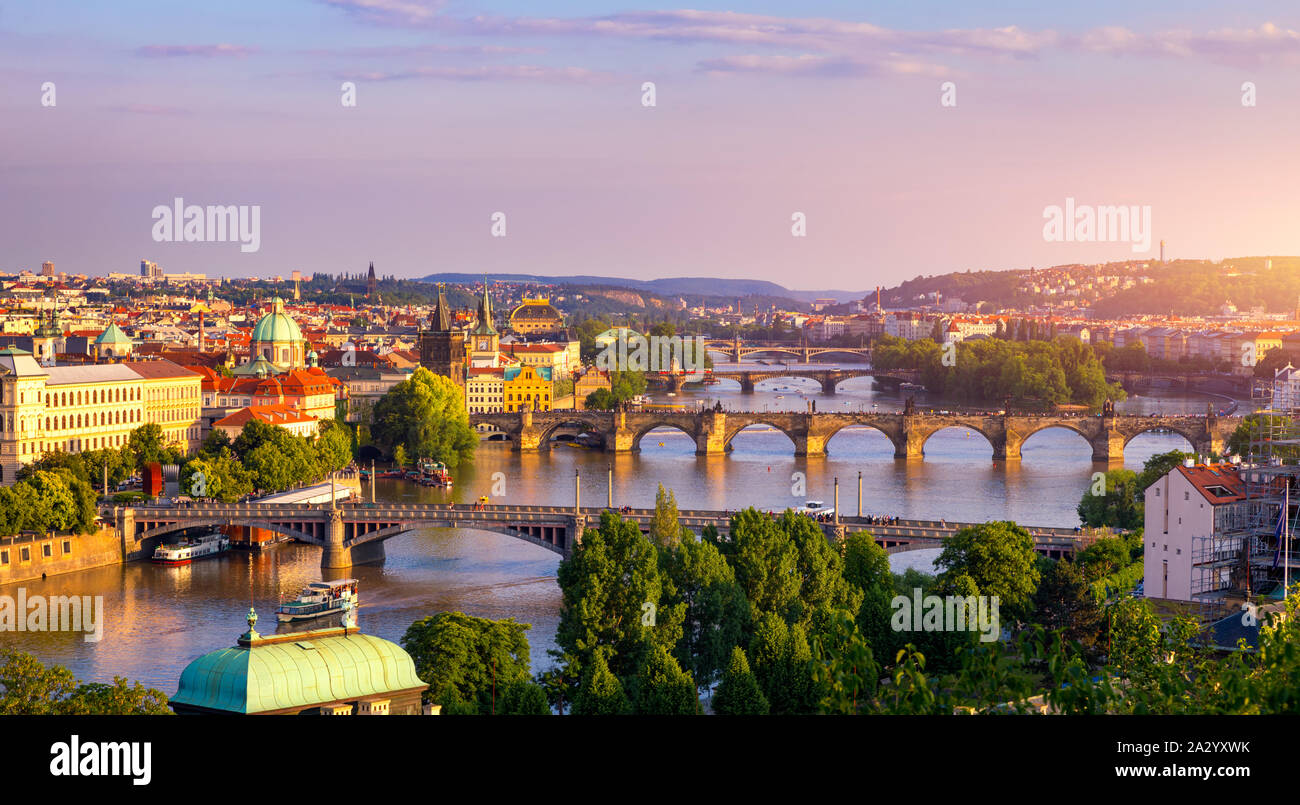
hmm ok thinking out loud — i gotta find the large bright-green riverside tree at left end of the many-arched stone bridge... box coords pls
[371,367,478,467]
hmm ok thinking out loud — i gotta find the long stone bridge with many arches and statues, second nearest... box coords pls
[469,411,1240,463]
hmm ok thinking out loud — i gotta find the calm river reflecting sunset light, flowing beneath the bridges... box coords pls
[0,378,1242,694]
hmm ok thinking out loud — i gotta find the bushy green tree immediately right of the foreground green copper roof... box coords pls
[402,613,533,715]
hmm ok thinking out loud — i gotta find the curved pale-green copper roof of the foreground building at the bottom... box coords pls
[170,632,425,714]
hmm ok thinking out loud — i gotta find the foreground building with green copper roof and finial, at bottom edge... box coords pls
[168,609,429,715]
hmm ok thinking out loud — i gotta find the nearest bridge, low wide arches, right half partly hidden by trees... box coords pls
[113,501,1083,568]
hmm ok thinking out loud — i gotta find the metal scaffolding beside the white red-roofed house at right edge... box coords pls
[1192,381,1300,618]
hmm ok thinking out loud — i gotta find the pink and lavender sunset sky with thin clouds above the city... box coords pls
[0,0,1300,290]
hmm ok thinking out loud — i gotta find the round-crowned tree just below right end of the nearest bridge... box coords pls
[935,521,1039,618]
